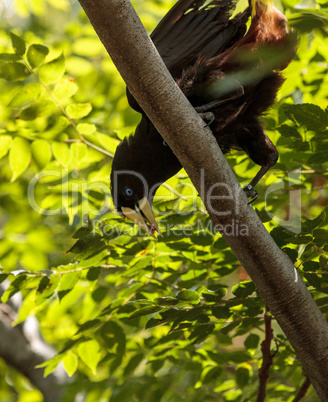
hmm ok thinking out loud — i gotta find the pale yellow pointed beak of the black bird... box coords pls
[122,197,163,239]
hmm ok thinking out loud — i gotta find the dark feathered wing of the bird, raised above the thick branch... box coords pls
[151,0,250,78]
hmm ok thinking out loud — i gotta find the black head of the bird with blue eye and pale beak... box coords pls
[111,139,162,238]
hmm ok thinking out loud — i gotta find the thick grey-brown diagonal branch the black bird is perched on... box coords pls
[75,0,328,400]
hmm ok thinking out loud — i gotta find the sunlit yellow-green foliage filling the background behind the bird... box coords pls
[0,0,328,401]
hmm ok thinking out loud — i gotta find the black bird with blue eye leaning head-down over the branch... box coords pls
[111,0,296,237]
